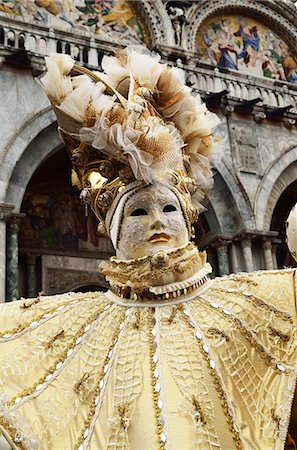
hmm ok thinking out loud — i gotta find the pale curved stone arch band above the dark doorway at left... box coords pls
[0,107,57,206]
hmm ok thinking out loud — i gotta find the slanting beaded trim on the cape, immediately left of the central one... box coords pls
[74,310,130,450]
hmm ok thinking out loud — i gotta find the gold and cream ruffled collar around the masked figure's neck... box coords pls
[100,243,212,303]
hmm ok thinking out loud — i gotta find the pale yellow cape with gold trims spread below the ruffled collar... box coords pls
[0,270,296,450]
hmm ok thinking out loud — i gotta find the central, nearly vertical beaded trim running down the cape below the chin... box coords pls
[149,308,168,450]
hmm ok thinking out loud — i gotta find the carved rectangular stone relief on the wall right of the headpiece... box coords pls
[230,123,259,174]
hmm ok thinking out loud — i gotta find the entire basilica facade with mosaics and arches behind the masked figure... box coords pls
[0,0,297,301]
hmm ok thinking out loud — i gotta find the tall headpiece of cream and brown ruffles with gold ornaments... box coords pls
[41,47,218,237]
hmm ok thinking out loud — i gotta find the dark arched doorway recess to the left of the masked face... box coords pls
[19,148,113,297]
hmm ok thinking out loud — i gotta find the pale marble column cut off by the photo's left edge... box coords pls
[0,203,14,303]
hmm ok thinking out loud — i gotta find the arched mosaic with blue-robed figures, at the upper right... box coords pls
[196,15,297,84]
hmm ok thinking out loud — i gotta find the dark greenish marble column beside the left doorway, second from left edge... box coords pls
[6,213,25,302]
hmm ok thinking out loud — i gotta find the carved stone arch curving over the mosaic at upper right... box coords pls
[185,0,297,51]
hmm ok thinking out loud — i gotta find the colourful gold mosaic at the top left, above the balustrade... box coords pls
[0,0,150,46]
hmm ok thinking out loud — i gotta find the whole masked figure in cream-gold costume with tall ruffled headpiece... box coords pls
[0,49,296,450]
